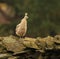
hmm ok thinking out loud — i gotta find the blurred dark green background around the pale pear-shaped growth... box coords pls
[0,0,60,37]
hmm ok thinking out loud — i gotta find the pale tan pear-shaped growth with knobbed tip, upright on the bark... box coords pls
[16,13,28,37]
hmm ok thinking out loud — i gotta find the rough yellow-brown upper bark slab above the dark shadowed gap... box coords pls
[2,36,60,52]
